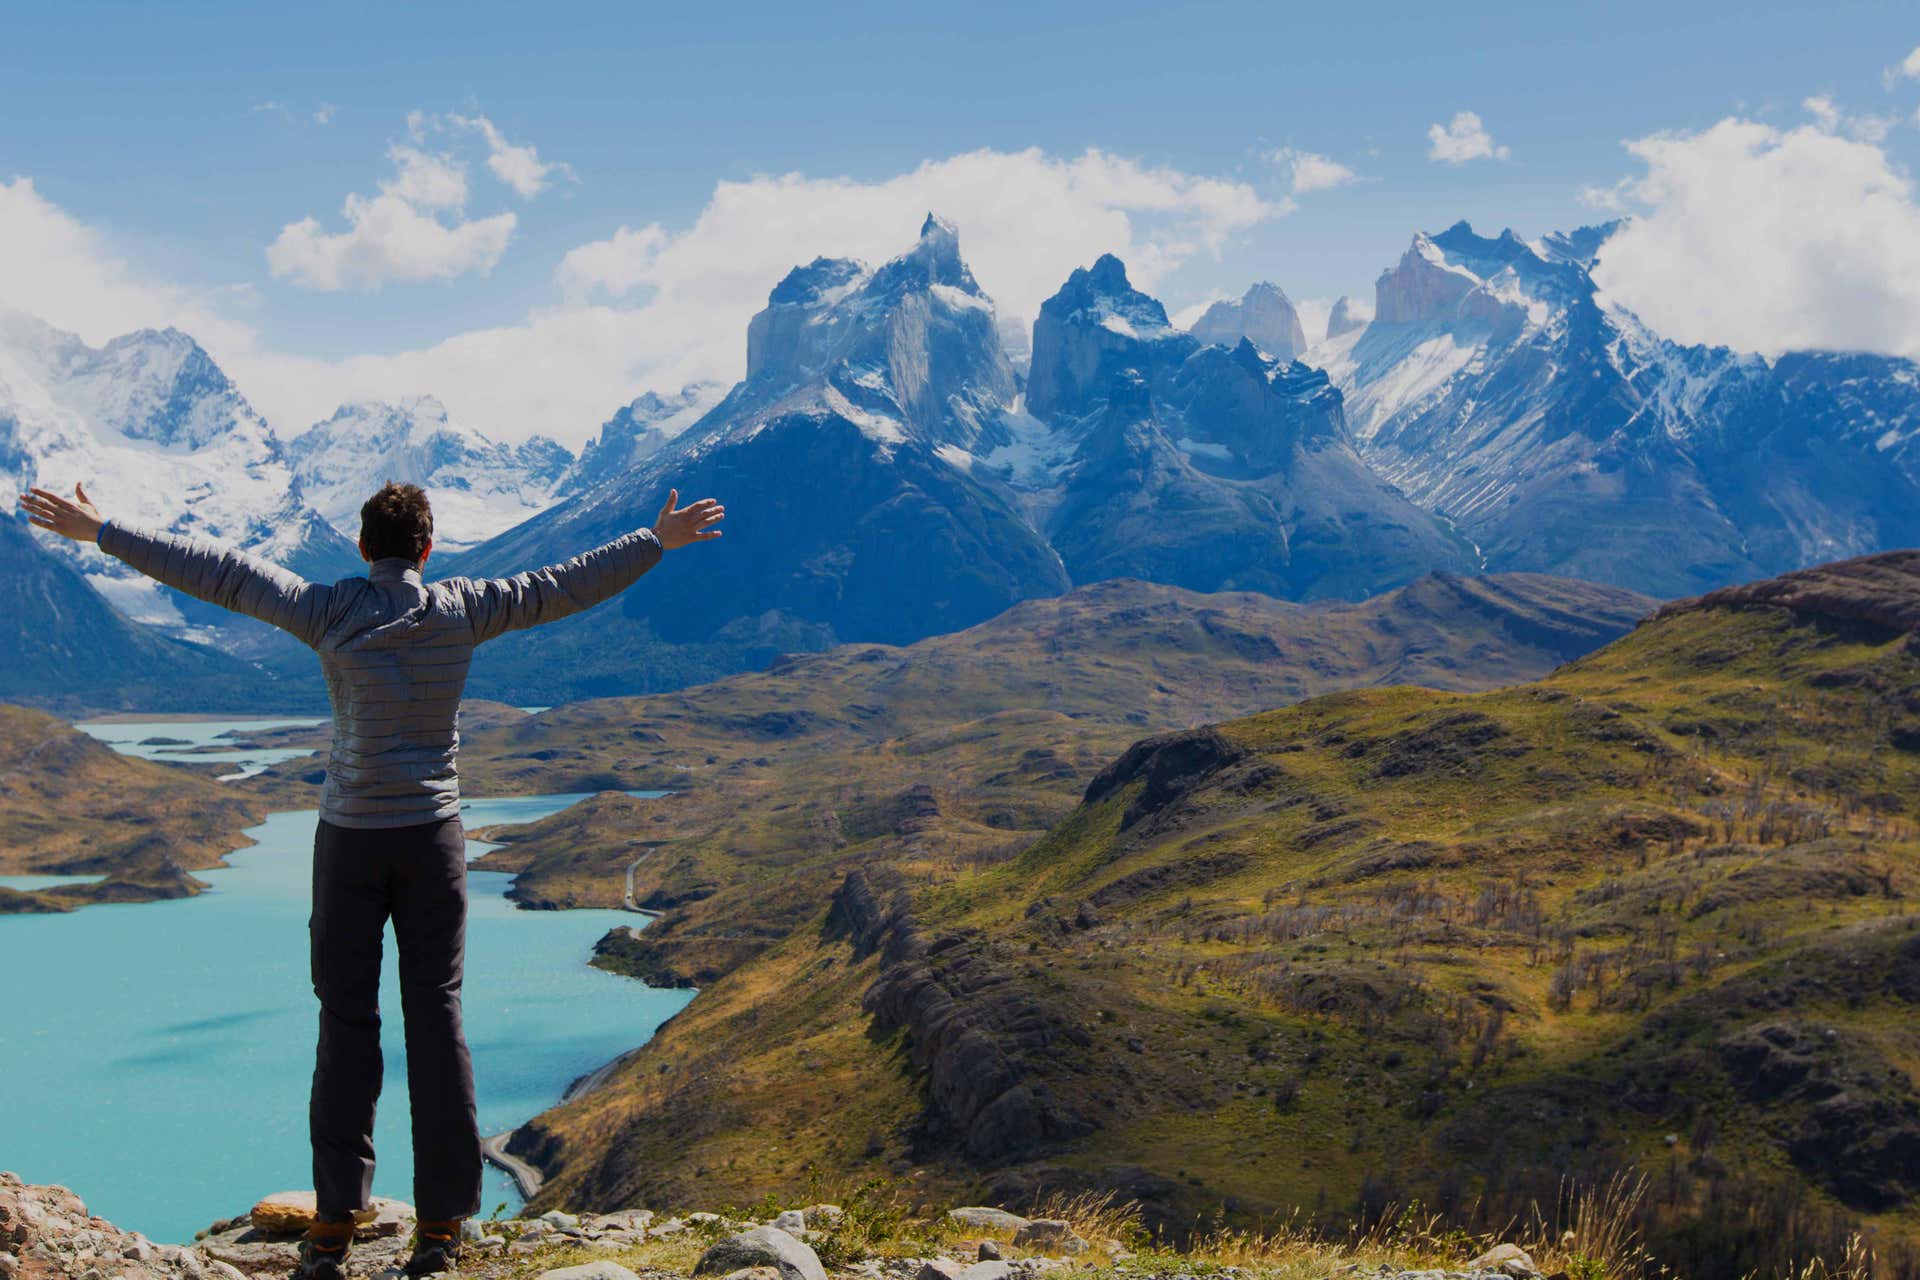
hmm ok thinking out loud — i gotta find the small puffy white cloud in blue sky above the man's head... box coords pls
[267,146,515,294]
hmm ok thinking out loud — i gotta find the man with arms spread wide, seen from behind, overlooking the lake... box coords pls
[19,484,726,1280]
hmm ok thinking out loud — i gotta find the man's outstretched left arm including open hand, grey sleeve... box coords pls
[19,486,330,645]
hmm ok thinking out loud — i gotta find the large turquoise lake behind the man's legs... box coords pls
[0,723,691,1242]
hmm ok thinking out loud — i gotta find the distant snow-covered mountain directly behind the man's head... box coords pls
[286,395,574,551]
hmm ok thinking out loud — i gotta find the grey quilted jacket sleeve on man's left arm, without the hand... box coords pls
[100,520,332,645]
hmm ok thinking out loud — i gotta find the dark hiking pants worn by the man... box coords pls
[307,818,480,1221]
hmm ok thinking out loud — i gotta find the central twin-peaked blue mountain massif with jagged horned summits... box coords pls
[447,215,1471,667]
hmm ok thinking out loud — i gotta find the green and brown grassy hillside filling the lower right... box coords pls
[520,553,1920,1276]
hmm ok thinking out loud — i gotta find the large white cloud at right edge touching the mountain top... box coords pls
[1596,113,1920,355]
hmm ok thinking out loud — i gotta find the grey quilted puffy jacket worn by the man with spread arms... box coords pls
[100,520,660,827]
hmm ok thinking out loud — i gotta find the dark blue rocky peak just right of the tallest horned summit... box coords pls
[1027,255,1473,599]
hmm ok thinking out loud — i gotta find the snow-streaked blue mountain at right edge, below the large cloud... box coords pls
[1309,223,1920,595]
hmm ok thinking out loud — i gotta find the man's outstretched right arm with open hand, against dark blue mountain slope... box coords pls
[460,489,726,645]
